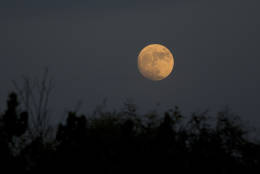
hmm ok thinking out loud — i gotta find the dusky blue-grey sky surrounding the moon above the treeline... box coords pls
[0,0,260,128]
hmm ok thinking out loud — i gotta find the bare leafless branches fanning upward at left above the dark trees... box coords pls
[13,68,54,140]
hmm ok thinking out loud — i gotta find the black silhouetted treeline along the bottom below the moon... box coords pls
[0,93,260,174]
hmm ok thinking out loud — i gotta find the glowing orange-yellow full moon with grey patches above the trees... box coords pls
[138,44,174,81]
